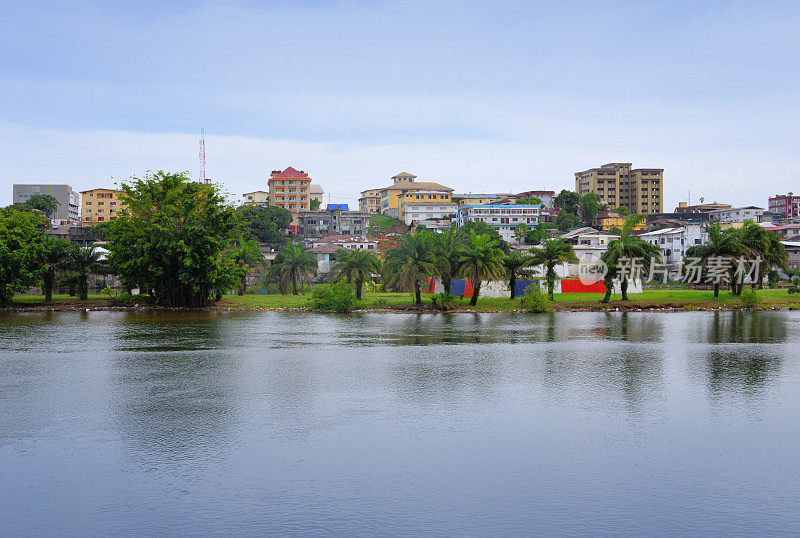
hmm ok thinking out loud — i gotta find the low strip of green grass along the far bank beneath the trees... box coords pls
[3,289,800,312]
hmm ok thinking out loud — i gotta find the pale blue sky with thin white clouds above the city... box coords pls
[0,0,800,207]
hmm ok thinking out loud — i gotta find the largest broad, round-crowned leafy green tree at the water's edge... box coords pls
[107,171,241,308]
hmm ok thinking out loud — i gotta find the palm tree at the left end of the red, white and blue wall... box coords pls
[384,230,439,305]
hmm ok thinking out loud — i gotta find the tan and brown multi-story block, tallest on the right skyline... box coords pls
[575,163,664,215]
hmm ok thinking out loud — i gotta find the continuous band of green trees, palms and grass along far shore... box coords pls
[0,172,800,311]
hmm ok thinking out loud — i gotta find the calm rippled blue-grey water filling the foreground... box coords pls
[0,312,800,535]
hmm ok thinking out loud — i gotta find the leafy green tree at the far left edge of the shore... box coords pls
[0,208,47,305]
